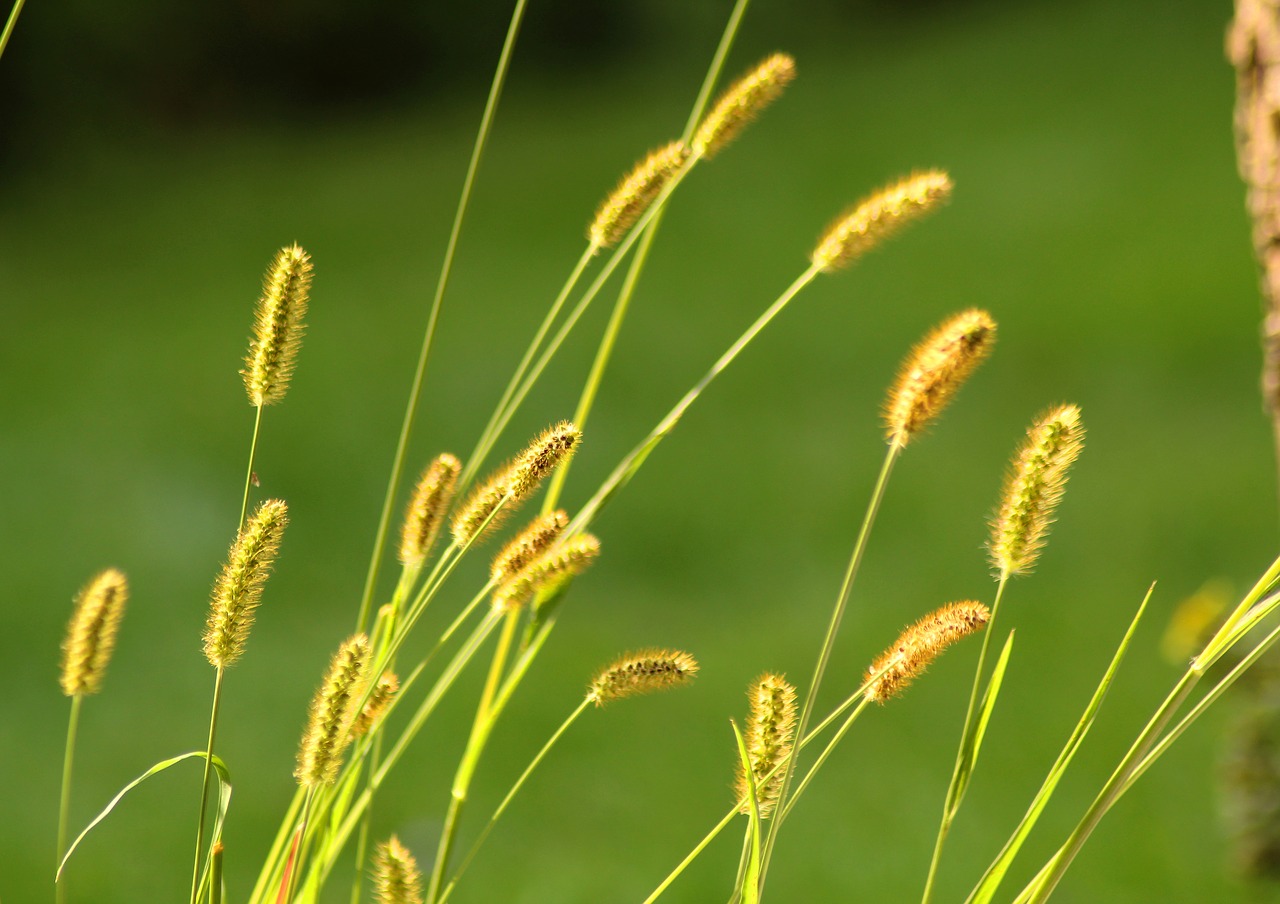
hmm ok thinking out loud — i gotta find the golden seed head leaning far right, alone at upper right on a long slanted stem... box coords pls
[809,169,951,267]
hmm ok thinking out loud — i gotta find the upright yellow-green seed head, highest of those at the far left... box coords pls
[241,245,311,407]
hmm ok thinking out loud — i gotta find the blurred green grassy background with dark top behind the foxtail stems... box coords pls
[0,0,1277,904]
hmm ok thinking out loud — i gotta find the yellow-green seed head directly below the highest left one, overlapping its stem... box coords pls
[205,499,289,668]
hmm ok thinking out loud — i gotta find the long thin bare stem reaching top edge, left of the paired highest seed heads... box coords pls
[356,0,526,631]
